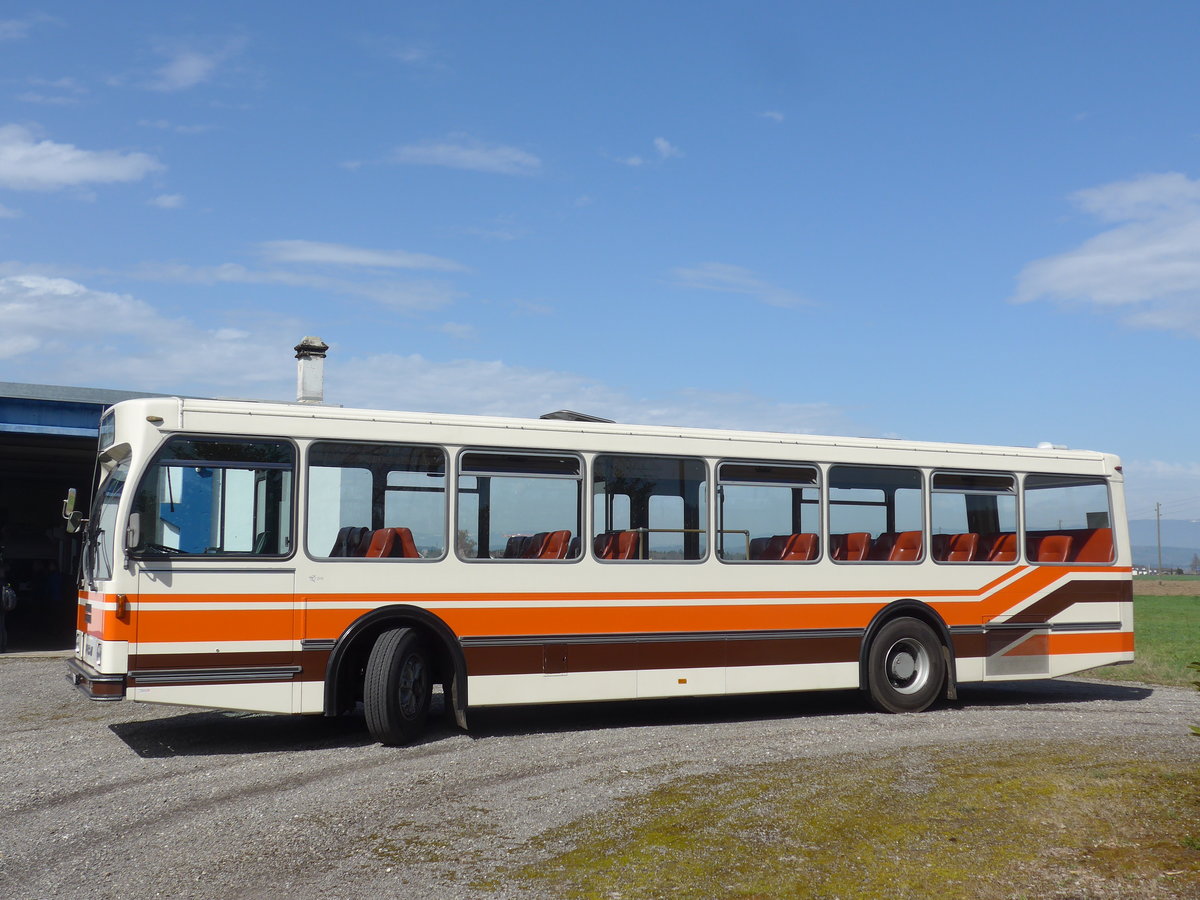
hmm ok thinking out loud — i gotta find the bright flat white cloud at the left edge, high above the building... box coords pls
[0,125,164,191]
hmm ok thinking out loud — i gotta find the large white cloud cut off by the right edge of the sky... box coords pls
[1012,173,1200,337]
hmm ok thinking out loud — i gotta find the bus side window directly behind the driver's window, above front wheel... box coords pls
[307,440,446,559]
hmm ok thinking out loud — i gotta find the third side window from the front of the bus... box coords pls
[455,451,583,562]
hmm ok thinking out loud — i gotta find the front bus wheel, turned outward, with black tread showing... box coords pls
[362,628,433,746]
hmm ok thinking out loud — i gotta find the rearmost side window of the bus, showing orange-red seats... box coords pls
[1025,475,1114,565]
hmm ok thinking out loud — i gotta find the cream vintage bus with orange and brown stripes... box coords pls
[68,397,1133,744]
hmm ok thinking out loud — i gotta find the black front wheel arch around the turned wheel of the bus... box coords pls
[325,604,467,728]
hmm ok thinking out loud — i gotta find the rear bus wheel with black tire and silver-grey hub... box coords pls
[866,616,946,713]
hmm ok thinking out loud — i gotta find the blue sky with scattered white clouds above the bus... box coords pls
[0,2,1200,518]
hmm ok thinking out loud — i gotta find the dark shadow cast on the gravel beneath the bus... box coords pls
[109,679,1153,758]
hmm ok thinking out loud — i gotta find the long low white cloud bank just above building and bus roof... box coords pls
[0,266,857,433]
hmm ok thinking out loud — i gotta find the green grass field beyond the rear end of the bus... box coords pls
[1087,596,1200,685]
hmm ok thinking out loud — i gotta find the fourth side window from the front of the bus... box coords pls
[592,455,708,560]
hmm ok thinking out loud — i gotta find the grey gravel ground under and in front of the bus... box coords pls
[0,656,1200,900]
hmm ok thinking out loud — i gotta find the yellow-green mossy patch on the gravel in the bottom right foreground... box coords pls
[489,743,1200,900]
